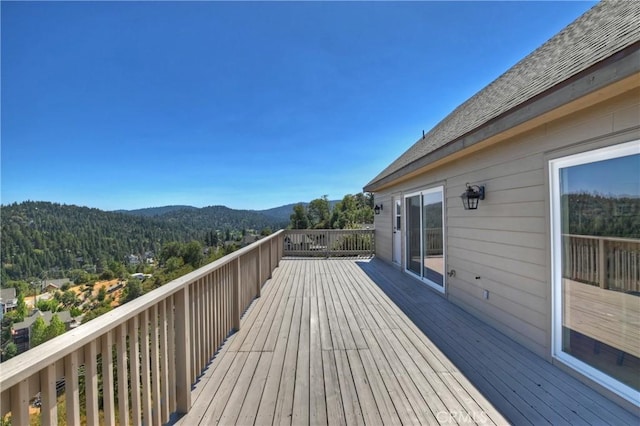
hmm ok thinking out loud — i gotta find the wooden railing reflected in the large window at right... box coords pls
[562,234,640,292]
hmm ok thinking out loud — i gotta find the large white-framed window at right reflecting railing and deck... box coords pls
[550,141,640,404]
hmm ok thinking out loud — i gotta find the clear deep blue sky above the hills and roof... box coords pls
[1,1,594,210]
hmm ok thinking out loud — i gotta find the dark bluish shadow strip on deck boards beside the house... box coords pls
[357,259,640,425]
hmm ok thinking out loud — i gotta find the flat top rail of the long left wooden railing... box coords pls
[0,230,284,390]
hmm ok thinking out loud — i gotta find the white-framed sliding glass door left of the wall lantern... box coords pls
[405,187,444,291]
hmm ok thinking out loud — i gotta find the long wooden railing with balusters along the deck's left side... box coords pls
[0,231,285,425]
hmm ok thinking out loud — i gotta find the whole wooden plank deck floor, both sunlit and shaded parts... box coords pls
[175,259,639,425]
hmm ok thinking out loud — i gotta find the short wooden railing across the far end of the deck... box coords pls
[283,229,375,257]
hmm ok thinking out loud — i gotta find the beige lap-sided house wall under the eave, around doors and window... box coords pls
[375,88,640,359]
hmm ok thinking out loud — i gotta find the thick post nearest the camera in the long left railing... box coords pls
[175,286,191,414]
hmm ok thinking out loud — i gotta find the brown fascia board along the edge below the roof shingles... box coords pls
[364,43,640,192]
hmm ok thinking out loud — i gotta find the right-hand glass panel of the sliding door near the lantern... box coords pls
[422,191,444,286]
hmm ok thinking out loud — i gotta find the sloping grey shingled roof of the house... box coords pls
[364,1,640,192]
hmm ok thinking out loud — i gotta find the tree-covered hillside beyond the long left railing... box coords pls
[0,201,286,282]
